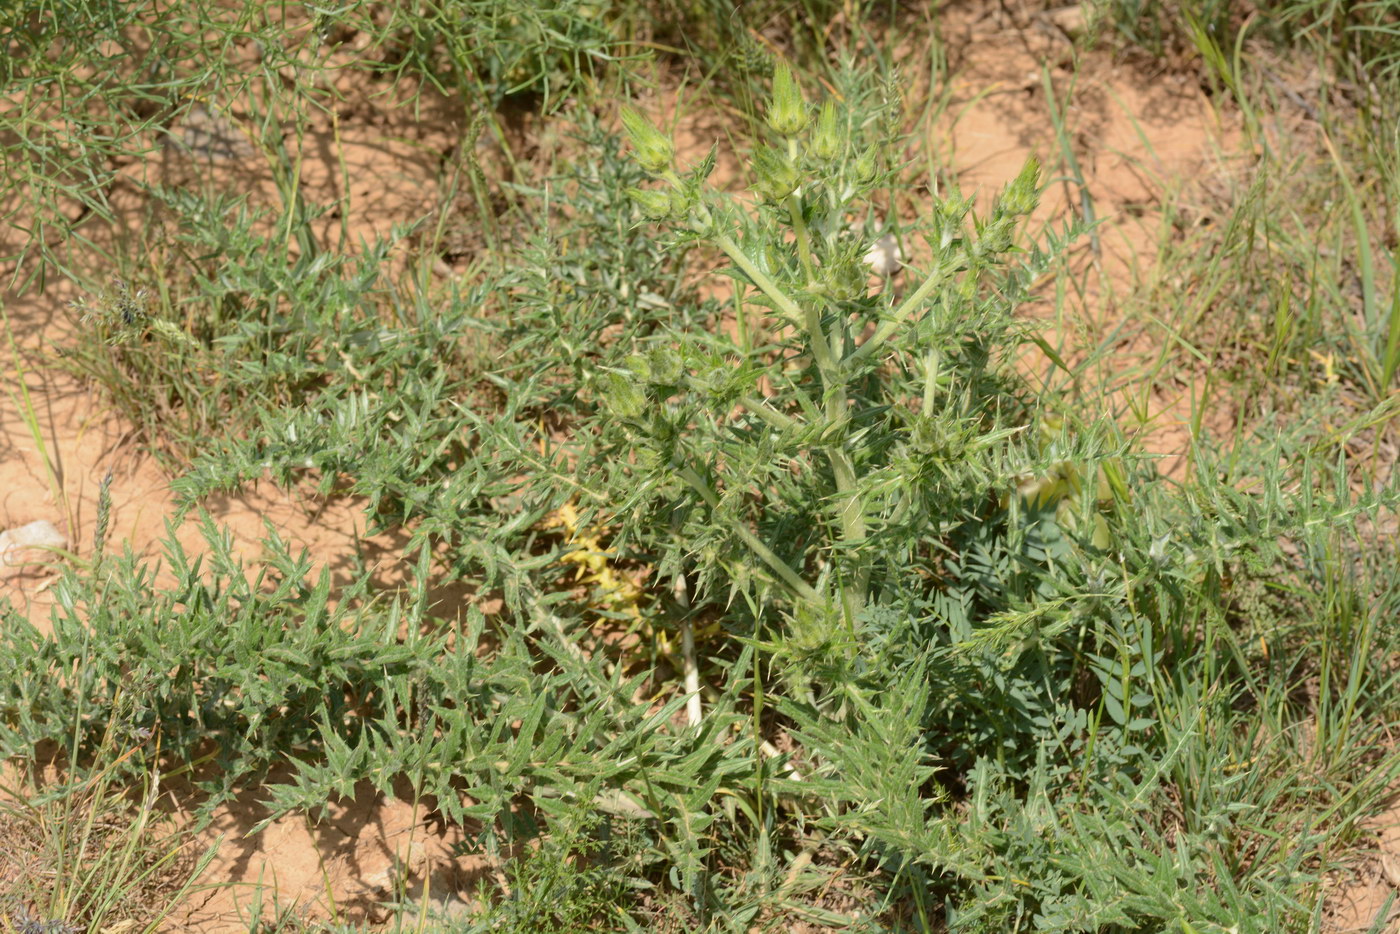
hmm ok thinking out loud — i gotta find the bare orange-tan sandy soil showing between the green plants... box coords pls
[0,5,1400,933]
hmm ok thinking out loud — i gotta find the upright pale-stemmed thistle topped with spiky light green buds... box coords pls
[605,66,1046,658]
